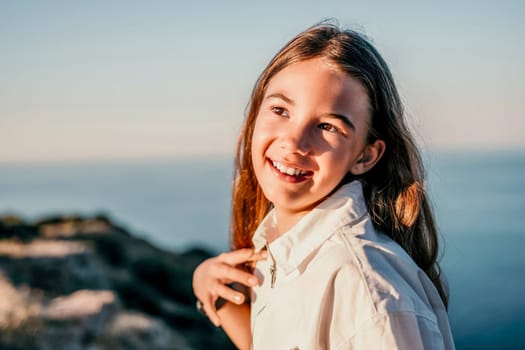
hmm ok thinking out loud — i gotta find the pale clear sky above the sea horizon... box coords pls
[0,0,525,162]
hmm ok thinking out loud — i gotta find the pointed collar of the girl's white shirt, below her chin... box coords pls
[252,181,367,274]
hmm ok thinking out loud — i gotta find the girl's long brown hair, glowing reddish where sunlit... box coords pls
[231,23,448,305]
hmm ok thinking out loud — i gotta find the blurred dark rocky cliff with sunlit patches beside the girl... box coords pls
[0,216,234,350]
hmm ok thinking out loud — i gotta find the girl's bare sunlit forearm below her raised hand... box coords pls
[218,303,252,350]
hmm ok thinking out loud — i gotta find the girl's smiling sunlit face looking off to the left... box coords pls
[251,58,378,226]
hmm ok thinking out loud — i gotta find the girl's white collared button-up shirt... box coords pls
[251,181,454,350]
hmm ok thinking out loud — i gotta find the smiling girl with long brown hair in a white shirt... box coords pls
[193,24,454,349]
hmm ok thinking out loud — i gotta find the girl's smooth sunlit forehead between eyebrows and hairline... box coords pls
[265,58,370,114]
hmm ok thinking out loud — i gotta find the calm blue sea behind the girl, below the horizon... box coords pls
[0,150,525,349]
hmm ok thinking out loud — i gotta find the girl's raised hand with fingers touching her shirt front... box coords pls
[193,248,267,327]
